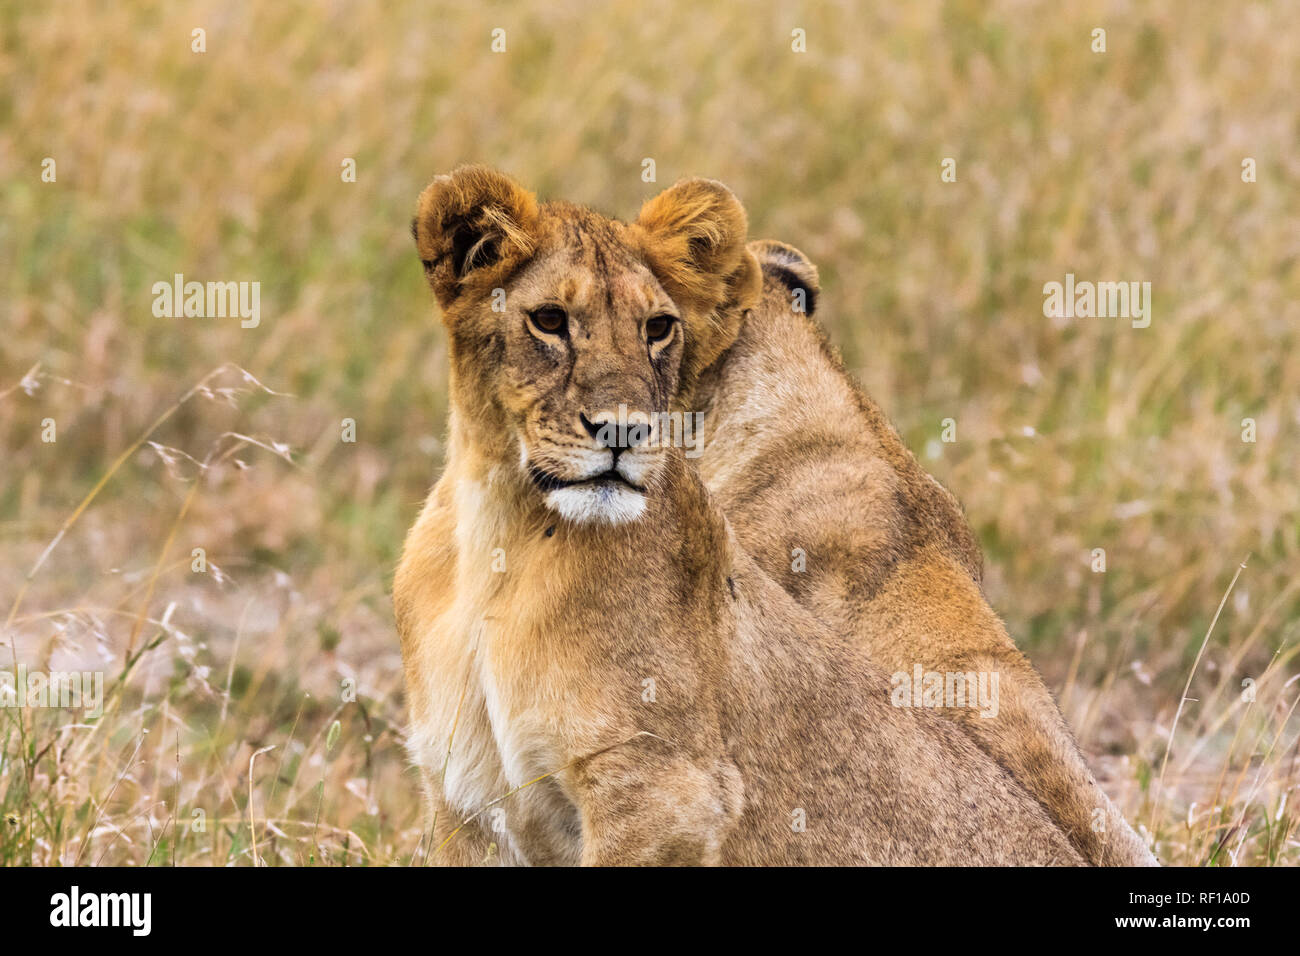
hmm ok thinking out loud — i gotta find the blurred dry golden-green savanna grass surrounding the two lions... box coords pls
[0,0,1300,865]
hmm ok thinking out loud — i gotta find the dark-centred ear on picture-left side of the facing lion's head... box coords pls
[411,166,538,308]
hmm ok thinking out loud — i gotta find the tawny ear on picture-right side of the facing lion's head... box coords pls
[634,179,763,377]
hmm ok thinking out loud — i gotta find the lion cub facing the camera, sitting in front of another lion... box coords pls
[394,168,1080,865]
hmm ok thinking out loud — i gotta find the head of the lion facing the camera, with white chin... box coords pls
[412,166,762,524]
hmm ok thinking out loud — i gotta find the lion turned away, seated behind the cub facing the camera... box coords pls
[696,242,1156,865]
